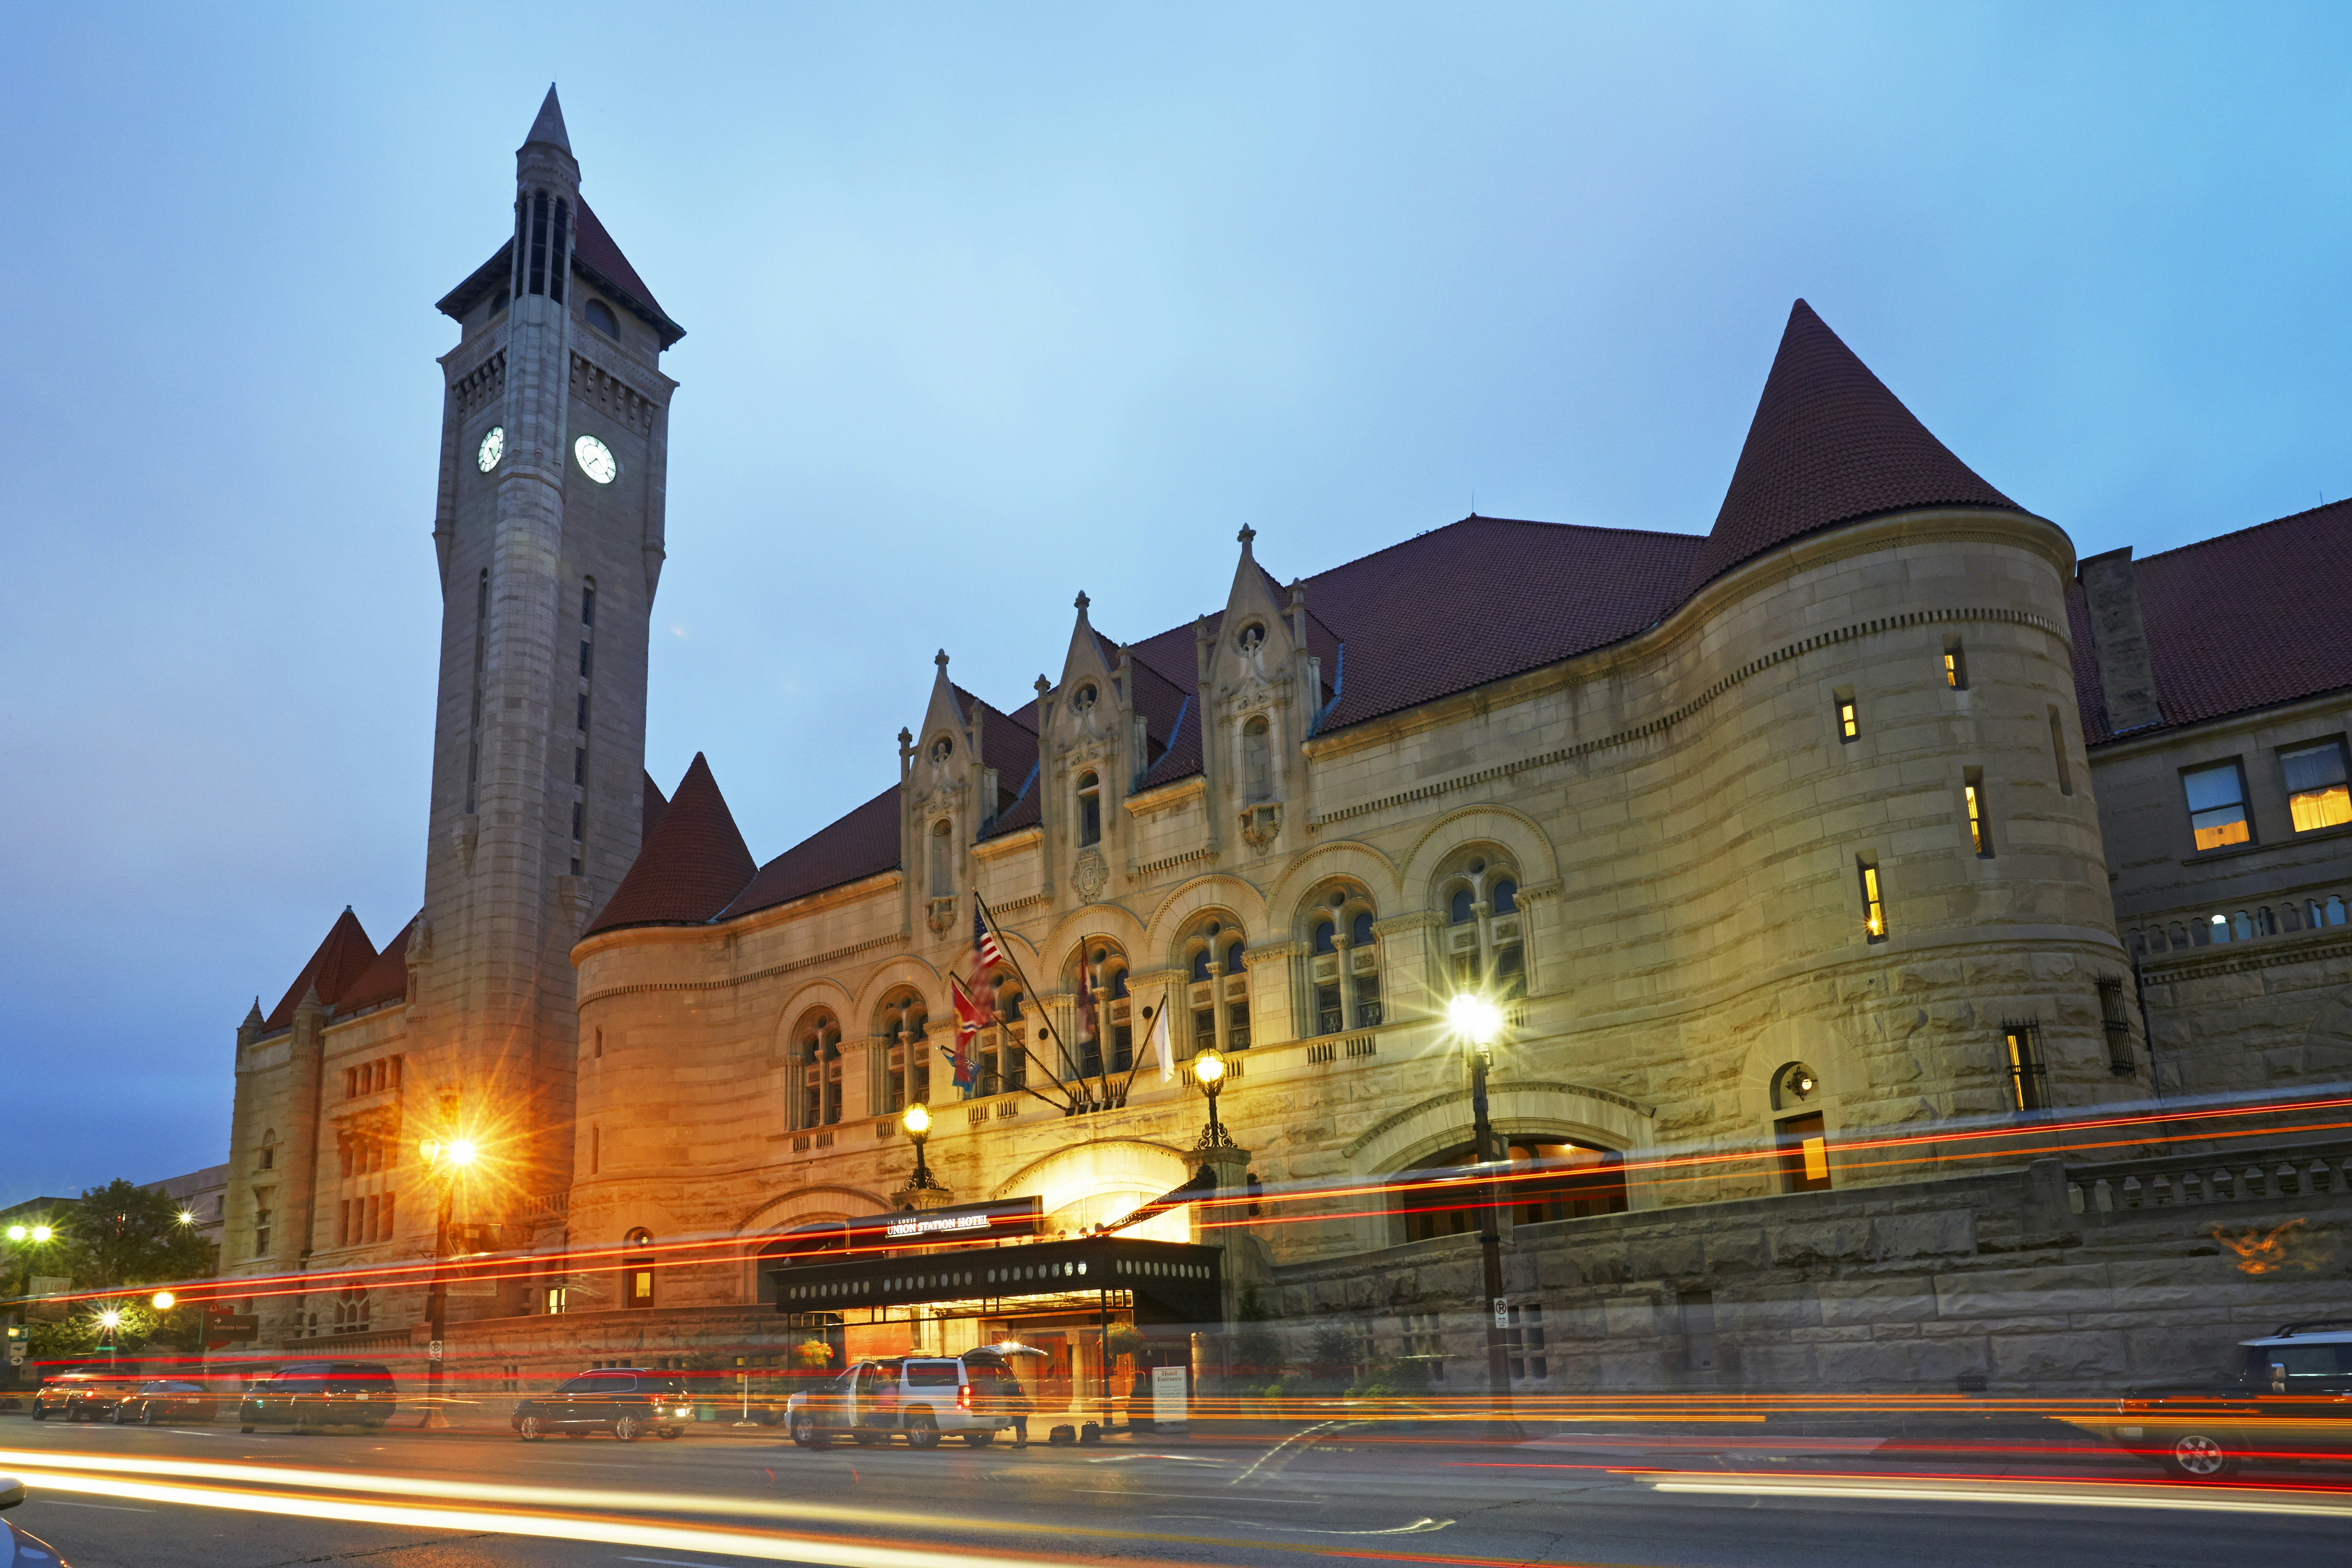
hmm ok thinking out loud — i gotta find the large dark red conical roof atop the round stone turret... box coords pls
[1687,298,2025,593]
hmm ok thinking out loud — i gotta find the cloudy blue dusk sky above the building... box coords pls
[0,0,2352,1201]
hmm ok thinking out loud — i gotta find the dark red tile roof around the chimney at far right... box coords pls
[2067,501,2352,745]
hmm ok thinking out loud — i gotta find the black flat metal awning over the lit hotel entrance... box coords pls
[769,1236,1225,1326]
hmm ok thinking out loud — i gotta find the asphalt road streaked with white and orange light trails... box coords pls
[0,1415,2352,1568]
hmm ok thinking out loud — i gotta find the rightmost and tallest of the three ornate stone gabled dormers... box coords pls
[1197,529,1322,851]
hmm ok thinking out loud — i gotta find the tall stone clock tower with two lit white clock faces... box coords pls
[407,87,684,1213]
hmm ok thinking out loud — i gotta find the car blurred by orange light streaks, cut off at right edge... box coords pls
[2108,1319,2352,1481]
